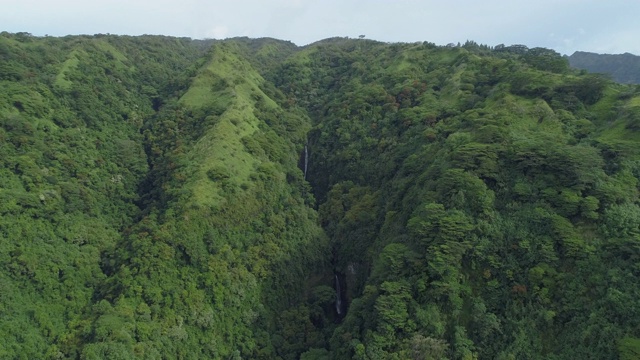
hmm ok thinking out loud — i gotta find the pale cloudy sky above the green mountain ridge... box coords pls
[0,0,640,55]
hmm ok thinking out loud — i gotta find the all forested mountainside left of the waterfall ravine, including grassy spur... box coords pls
[0,34,326,359]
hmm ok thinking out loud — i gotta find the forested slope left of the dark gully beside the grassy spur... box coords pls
[0,34,198,359]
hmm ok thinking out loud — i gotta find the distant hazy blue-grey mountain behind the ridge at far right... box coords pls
[569,51,640,84]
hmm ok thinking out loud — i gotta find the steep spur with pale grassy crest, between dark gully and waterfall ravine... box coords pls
[77,43,326,358]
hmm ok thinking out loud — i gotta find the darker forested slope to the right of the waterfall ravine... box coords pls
[281,39,640,359]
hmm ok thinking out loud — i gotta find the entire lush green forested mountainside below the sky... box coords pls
[0,32,640,360]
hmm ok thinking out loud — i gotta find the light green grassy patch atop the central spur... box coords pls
[180,45,277,208]
